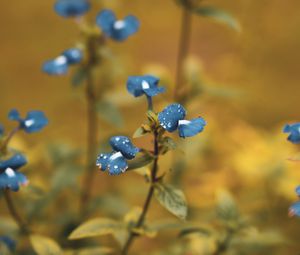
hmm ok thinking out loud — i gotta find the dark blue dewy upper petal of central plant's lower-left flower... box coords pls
[109,136,140,159]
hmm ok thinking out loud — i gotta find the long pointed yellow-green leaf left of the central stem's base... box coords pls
[69,218,122,240]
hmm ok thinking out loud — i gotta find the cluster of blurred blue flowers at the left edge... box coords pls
[0,109,48,191]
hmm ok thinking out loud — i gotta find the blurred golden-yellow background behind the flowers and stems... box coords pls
[0,0,300,254]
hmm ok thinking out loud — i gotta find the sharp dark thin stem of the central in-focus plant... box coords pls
[121,130,159,255]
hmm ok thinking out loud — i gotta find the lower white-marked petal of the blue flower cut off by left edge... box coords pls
[0,168,28,191]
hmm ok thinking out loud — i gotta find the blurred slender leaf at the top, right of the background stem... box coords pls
[192,6,241,32]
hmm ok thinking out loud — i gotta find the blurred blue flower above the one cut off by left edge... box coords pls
[8,109,48,133]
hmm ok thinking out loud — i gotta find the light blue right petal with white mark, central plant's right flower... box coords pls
[178,117,206,138]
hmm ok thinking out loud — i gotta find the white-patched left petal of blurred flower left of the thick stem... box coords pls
[42,56,68,75]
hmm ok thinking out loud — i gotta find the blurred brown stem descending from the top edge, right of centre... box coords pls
[174,7,192,103]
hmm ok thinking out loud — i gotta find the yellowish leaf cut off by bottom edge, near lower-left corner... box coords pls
[30,235,62,255]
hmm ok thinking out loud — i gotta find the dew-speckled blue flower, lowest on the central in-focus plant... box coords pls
[96,136,140,175]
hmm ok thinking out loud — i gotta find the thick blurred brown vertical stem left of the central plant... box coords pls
[80,68,97,214]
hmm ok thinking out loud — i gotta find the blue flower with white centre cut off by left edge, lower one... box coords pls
[0,153,28,191]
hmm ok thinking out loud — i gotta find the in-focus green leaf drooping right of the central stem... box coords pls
[155,183,187,220]
